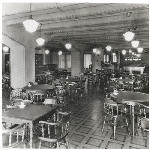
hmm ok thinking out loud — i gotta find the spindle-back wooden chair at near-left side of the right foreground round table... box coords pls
[102,98,129,139]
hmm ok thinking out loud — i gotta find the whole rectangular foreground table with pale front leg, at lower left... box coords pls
[2,104,55,149]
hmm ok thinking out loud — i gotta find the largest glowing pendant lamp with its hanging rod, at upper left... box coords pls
[23,3,39,33]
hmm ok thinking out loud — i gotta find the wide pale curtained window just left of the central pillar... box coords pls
[59,54,71,68]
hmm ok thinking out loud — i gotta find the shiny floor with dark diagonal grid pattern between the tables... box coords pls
[2,85,148,149]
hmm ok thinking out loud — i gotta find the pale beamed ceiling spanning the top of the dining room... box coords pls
[2,3,149,50]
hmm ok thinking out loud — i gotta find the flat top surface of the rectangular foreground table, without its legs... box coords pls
[2,104,55,121]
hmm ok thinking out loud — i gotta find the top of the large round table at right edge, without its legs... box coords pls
[111,91,149,102]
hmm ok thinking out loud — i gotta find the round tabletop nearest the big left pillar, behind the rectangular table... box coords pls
[23,84,55,90]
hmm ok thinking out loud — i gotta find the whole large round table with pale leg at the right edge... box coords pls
[110,91,149,136]
